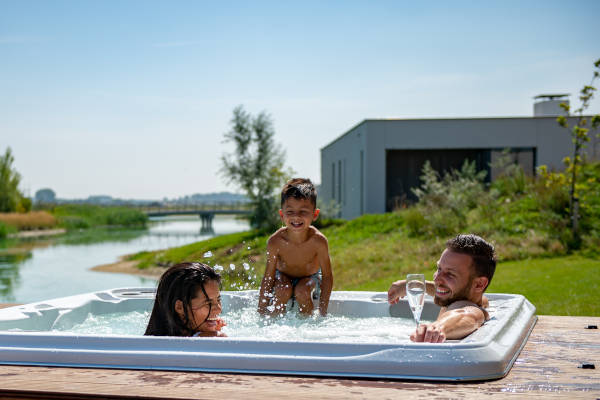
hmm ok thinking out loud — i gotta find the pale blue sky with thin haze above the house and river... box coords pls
[0,0,600,198]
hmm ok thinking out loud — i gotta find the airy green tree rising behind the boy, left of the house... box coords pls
[221,105,286,229]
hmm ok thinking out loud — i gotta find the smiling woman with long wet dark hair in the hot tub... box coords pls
[145,263,226,336]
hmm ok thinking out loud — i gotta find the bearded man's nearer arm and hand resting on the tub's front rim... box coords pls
[410,303,487,343]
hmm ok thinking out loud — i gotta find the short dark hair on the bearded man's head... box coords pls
[446,234,496,289]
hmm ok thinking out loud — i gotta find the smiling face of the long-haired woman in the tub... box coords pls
[178,281,222,335]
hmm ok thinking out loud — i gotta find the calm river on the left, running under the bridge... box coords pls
[0,216,249,303]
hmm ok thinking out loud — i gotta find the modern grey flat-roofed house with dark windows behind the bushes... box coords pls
[319,95,600,219]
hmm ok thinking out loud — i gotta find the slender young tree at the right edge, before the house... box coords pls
[557,59,600,243]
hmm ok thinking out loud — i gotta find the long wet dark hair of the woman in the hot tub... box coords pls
[144,262,221,336]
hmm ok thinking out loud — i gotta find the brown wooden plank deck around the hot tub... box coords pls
[0,316,600,400]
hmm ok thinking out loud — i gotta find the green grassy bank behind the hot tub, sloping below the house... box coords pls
[130,213,600,316]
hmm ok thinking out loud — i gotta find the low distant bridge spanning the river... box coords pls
[140,203,252,232]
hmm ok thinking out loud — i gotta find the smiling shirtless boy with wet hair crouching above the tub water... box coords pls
[258,178,333,316]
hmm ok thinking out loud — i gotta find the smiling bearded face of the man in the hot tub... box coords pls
[433,249,475,307]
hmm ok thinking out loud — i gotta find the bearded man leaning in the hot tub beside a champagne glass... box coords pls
[388,235,496,343]
